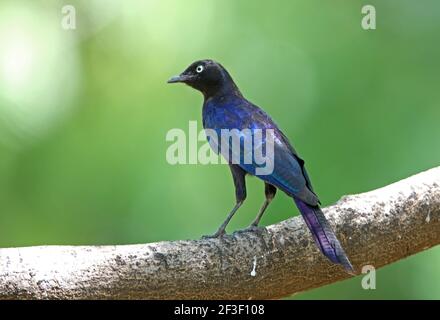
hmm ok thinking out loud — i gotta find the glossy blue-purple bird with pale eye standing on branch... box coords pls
[168,59,354,274]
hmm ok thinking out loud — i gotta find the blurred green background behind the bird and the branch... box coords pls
[0,0,440,299]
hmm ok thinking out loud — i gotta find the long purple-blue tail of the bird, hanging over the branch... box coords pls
[295,199,354,274]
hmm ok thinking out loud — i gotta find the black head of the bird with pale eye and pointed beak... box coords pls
[168,60,239,98]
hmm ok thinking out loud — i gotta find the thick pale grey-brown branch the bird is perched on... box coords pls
[0,167,440,299]
